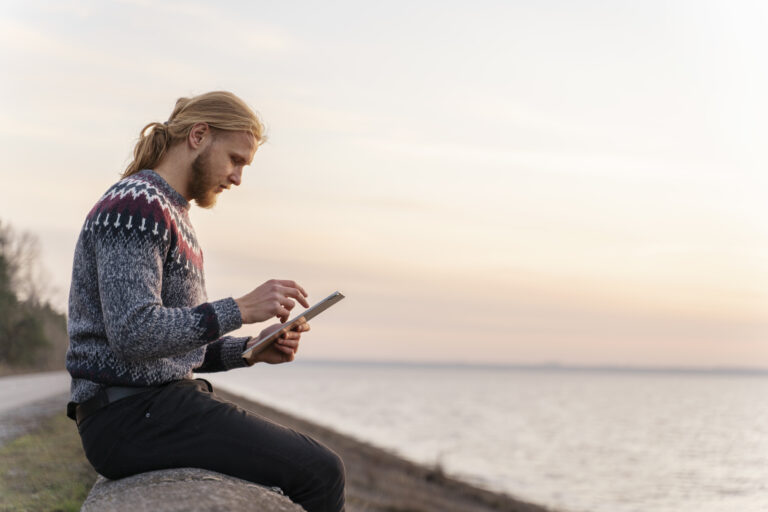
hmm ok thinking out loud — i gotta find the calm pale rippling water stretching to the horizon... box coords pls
[206,362,768,512]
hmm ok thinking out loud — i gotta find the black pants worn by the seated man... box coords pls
[78,379,344,512]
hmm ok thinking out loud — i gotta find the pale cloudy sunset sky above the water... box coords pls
[0,0,768,368]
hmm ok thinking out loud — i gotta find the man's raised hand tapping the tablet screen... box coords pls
[235,279,309,324]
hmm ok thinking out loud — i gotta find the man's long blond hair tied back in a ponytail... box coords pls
[122,91,266,178]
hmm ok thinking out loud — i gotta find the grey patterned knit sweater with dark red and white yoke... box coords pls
[66,170,249,403]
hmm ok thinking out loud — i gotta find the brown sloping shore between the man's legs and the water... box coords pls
[216,388,553,512]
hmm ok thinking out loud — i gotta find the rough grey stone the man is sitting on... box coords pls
[81,468,304,512]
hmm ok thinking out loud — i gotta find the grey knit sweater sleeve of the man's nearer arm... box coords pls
[93,200,242,361]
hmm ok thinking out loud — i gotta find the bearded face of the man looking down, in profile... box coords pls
[189,130,256,208]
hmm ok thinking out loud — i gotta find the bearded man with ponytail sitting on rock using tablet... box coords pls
[66,92,344,512]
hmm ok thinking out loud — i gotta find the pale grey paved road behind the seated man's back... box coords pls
[0,371,69,446]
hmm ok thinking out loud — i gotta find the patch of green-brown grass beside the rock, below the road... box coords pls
[0,414,97,512]
